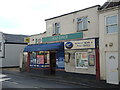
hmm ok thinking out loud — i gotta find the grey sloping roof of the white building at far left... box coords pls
[3,33,28,43]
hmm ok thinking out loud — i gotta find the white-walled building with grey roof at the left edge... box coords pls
[0,32,27,67]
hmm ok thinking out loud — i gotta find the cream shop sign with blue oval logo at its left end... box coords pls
[64,39,95,49]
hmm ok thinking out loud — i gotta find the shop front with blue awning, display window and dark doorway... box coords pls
[24,42,64,74]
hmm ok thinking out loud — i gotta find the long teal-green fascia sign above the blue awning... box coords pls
[42,32,83,42]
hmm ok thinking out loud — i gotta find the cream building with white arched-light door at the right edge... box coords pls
[99,0,120,84]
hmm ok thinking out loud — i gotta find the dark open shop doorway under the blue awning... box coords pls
[50,52,56,75]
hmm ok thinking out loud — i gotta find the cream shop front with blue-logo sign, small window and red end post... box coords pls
[64,38,100,80]
